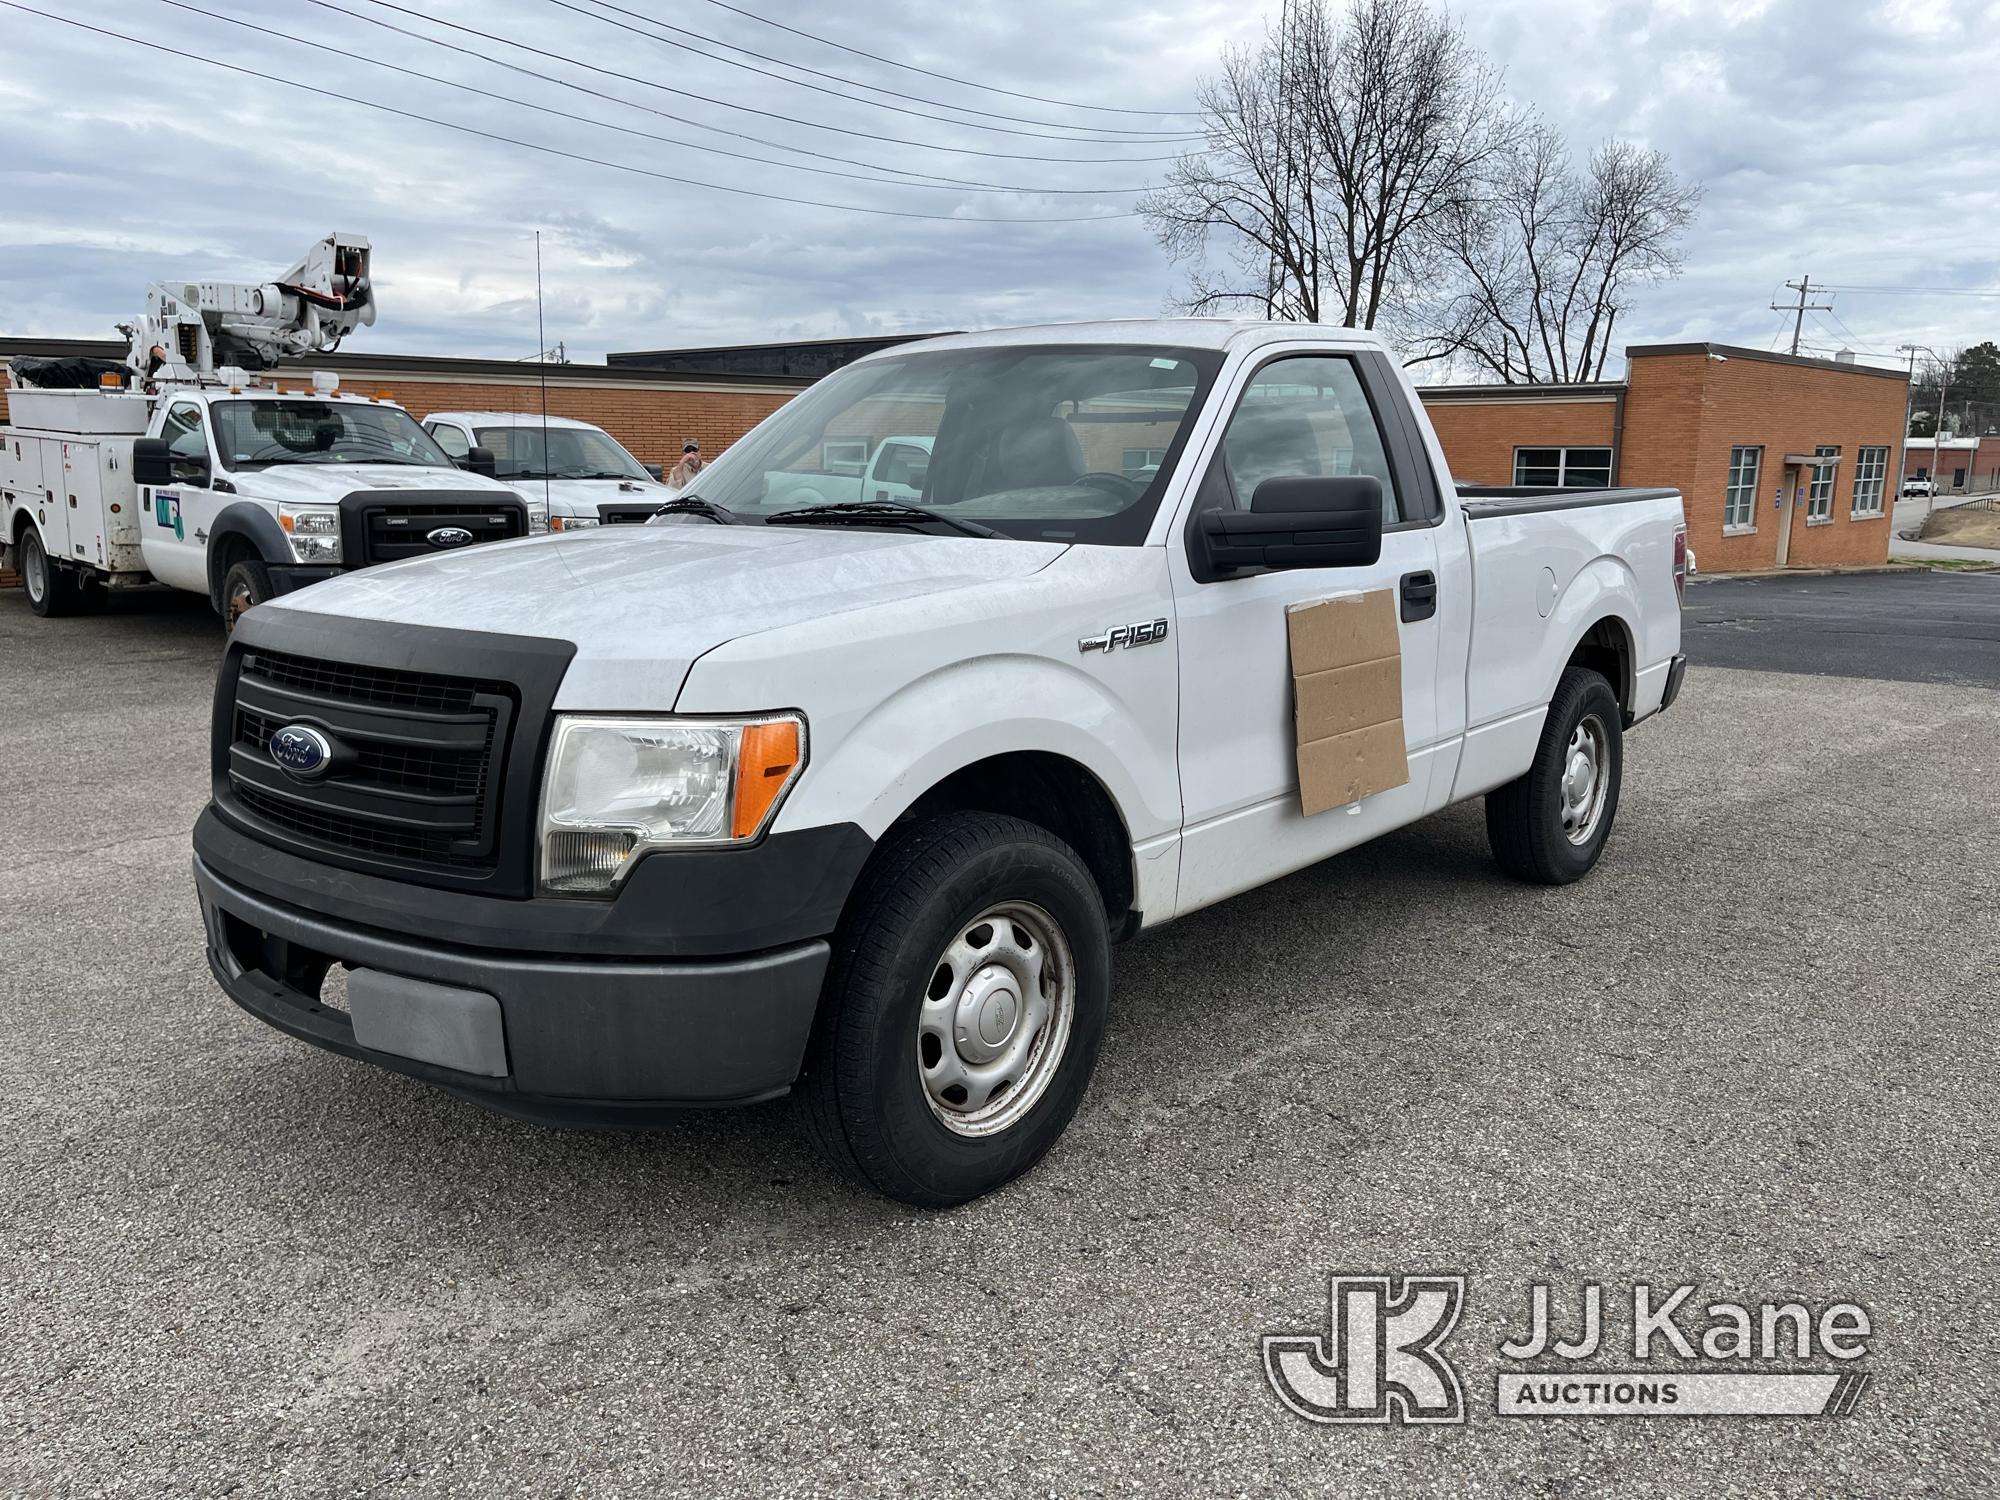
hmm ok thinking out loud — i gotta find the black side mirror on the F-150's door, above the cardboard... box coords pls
[1188,474,1382,584]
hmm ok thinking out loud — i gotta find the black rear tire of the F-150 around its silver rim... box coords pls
[1486,666,1624,886]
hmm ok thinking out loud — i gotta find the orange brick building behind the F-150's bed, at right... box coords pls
[1422,344,1908,572]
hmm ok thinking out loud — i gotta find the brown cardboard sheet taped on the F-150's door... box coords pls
[1284,588,1410,818]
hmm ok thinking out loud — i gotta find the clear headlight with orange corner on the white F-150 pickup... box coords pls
[542,714,806,896]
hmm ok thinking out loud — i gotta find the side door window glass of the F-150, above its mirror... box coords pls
[1200,354,1402,526]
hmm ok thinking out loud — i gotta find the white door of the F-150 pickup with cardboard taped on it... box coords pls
[1174,354,1458,912]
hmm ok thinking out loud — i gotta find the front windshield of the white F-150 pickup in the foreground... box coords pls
[686,344,1222,546]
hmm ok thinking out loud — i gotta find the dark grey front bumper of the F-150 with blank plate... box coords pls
[194,856,830,1124]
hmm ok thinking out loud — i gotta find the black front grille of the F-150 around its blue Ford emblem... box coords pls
[224,646,518,874]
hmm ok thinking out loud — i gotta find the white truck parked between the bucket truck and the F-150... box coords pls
[424,412,674,532]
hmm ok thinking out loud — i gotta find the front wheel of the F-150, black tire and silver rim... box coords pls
[798,812,1110,1208]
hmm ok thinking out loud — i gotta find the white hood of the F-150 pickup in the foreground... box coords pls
[278,522,1066,712]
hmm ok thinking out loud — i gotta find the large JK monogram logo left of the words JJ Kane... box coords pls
[1264,1276,1466,1424]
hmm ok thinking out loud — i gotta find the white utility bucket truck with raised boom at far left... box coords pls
[0,234,548,630]
